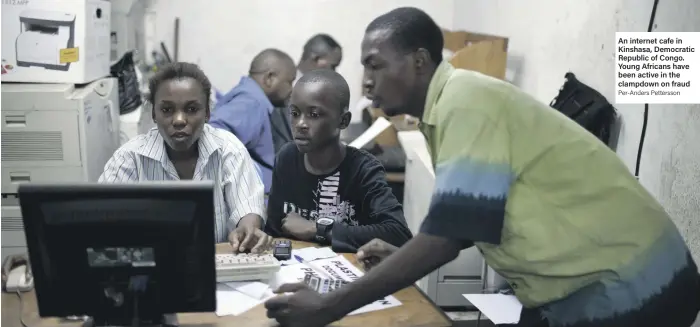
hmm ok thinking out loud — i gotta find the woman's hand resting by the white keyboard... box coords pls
[228,214,273,253]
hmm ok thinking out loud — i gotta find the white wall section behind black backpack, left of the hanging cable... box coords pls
[454,0,652,170]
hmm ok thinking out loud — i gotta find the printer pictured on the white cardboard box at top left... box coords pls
[15,9,75,71]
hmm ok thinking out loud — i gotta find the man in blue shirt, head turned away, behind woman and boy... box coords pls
[209,49,296,194]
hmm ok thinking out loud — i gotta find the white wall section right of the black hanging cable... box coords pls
[640,0,700,272]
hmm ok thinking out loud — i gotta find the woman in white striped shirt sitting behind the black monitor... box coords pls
[98,62,272,252]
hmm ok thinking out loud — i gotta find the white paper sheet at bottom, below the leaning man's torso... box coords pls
[462,294,523,325]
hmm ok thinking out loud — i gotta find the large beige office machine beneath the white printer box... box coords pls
[0,78,119,260]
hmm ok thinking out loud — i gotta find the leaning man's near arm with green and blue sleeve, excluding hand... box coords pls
[328,105,514,315]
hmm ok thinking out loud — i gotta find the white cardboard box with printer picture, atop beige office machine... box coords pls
[2,0,111,84]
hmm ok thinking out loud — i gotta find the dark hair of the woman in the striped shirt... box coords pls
[148,62,211,109]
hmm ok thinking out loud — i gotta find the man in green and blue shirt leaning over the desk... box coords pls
[265,8,700,327]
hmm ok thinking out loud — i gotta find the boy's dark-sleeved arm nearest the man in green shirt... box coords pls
[331,158,412,252]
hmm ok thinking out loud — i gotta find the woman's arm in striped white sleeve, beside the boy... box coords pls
[223,140,265,228]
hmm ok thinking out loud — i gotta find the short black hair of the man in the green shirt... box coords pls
[365,7,445,64]
